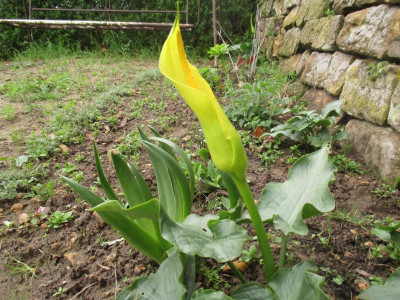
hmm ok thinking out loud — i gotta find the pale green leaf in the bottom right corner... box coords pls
[358,268,400,300]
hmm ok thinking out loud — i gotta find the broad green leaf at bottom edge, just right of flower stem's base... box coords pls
[269,260,329,300]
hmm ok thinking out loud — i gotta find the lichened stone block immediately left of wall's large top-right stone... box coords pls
[300,16,344,51]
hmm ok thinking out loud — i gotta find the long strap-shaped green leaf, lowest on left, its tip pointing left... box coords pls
[61,176,168,263]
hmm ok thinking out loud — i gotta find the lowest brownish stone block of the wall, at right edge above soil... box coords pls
[346,120,400,182]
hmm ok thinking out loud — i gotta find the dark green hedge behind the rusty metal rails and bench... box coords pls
[0,0,257,59]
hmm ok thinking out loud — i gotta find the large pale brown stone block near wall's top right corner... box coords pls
[336,5,400,60]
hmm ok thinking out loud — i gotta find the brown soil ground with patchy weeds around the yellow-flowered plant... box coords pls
[0,54,400,299]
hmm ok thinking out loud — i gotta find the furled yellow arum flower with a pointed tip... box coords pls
[159,13,247,180]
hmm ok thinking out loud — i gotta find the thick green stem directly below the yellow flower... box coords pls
[234,178,275,282]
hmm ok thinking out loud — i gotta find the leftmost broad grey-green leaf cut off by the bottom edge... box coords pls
[116,248,186,300]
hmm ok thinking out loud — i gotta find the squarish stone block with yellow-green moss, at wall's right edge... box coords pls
[340,59,400,125]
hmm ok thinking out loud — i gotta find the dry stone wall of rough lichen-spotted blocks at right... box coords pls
[259,0,400,181]
